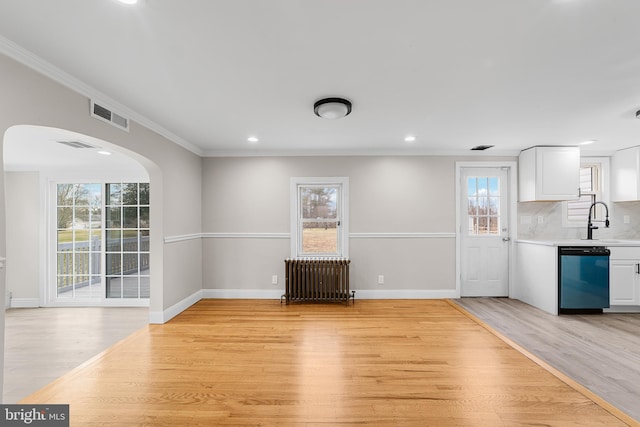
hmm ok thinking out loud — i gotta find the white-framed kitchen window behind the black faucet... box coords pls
[562,158,608,227]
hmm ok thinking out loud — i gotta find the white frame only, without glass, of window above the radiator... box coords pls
[290,177,349,258]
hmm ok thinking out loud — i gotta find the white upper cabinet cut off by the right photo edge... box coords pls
[611,147,640,202]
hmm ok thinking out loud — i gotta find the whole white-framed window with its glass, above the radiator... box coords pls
[291,178,348,257]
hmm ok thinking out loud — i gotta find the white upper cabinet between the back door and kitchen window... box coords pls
[518,146,580,202]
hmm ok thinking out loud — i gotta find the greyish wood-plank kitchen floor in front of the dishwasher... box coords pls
[455,298,640,423]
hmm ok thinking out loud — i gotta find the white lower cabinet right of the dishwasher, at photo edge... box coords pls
[609,247,640,305]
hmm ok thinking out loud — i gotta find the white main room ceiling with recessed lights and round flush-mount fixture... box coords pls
[0,0,640,160]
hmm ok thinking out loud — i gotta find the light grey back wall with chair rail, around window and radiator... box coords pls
[202,156,513,298]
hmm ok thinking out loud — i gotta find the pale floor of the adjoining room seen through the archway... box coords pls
[2,307,149,403]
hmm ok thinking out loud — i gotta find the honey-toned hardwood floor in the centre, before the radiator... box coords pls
[22,300,625,426]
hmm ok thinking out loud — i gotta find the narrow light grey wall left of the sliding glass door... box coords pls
[5,172,39,307]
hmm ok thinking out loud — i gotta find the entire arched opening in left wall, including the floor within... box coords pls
[3,125,160,403]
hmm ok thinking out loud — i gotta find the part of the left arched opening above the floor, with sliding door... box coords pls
[4,125,150,307]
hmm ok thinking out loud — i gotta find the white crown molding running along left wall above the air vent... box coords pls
[0,36,204,156]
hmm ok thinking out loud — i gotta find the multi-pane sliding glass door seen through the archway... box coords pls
[53,183,149,301]
